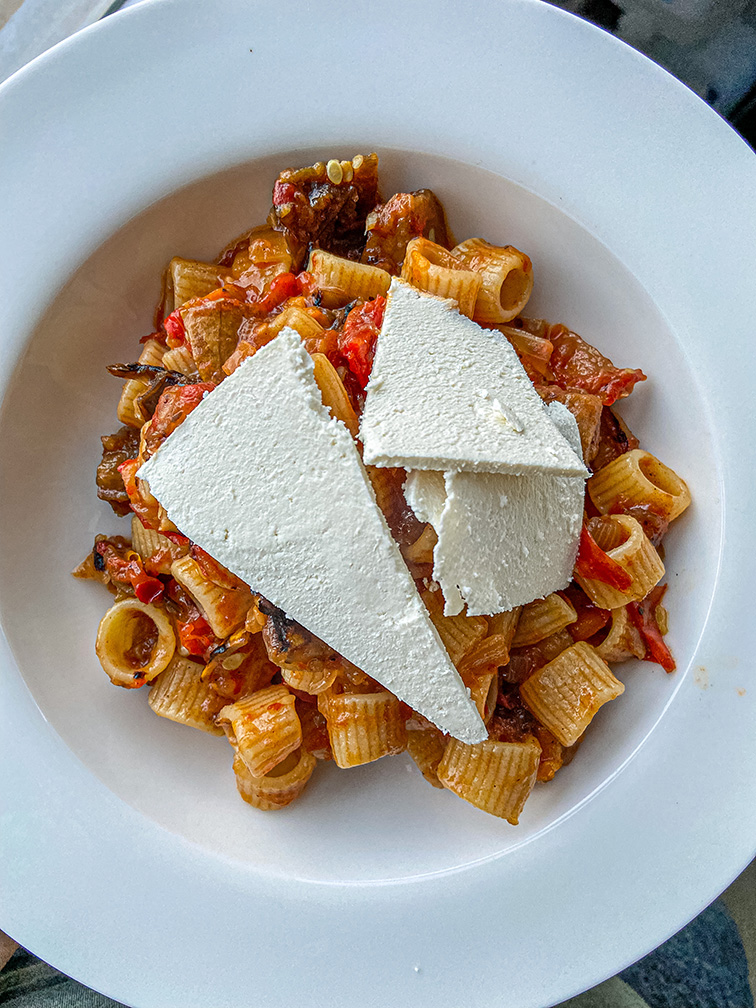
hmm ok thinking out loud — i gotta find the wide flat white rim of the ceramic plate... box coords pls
[0,0,756,1008]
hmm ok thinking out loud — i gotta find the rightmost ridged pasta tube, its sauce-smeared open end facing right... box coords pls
[587,448,690,521]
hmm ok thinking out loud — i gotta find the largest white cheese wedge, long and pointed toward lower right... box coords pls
[138,328,488,743]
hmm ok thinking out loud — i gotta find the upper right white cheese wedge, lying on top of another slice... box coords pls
[360,279,586,476]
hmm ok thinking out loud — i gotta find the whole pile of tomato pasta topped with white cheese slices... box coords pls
[75,154,690,825]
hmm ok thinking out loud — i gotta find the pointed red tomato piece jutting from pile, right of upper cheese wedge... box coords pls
[548,326,646,406]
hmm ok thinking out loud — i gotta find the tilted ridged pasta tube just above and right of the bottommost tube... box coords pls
[520,641,625,746]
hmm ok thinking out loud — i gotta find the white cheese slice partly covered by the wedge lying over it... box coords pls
[405,402,585,616]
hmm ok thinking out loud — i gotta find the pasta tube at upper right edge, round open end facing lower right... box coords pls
[452,238,533,324]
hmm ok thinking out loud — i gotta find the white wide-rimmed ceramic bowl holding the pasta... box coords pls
[0,0,756,1008]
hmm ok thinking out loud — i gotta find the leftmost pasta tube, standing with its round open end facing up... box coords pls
[95,599,175,688]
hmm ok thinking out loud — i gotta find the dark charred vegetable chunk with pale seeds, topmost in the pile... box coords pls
[269,154,380,271]
